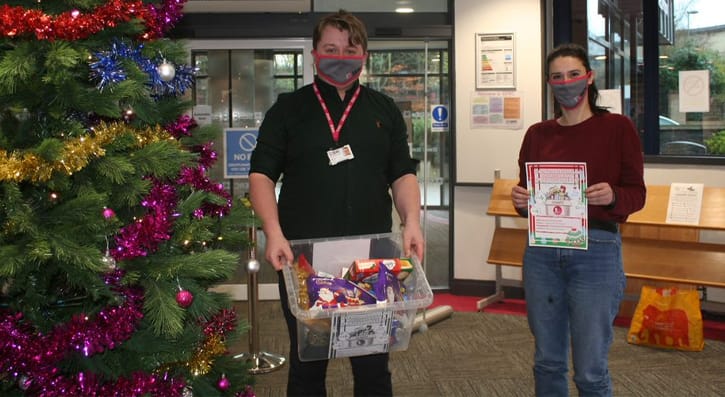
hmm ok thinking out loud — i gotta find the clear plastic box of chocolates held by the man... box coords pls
[282,233,433,361]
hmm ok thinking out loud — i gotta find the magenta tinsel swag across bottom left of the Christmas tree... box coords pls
[0,270,186,397]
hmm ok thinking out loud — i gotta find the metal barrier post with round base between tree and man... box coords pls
[234,218,286,374]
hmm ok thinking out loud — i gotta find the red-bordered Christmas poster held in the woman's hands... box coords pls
[526,162,589,250]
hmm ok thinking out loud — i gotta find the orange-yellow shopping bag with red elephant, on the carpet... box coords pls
[627,285,705,351]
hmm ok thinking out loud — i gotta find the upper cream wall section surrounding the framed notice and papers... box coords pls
[454,0,543,183]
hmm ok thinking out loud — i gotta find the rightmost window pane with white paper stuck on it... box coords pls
[658,0,725,156]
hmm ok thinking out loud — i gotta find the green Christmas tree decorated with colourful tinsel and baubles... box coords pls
[0,0,253,397]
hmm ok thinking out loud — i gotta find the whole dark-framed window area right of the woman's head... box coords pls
[571,0,725,162]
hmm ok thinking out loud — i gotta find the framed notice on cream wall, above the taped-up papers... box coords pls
[476,33,516,90]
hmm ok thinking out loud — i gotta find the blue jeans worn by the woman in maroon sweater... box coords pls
[523,229,626,397]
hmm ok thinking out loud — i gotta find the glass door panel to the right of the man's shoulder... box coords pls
[363,40,451,288]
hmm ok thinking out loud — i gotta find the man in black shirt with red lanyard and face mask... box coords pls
[249,10,425,396]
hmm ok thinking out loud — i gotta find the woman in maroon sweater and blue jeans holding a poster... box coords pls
[511,44,646,396]
